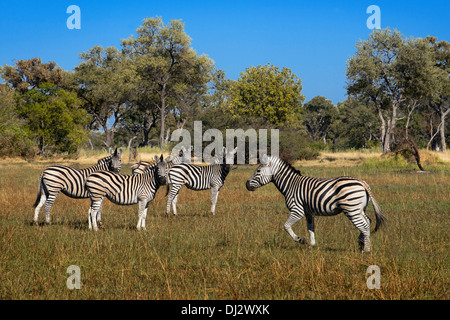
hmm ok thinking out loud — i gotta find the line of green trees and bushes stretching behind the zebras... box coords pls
[0,17,450,159]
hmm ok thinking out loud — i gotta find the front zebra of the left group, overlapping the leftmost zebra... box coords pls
[86,155,167,231]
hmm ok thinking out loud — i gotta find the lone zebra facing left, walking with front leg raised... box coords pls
[246,155,385,252]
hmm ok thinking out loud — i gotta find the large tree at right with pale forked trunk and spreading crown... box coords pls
[347,28,448,153]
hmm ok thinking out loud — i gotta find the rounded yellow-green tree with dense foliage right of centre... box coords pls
[227,64,305,126]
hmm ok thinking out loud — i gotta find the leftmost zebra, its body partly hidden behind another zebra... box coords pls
[33,148,122,224]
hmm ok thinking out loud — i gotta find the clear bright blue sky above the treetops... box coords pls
[0,0,450,104]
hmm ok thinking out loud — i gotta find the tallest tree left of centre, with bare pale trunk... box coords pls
[122,17,212,149]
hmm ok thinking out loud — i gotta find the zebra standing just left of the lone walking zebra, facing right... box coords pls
[166,148,237,216]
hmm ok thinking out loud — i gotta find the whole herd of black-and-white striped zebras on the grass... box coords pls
[34,148,385,252]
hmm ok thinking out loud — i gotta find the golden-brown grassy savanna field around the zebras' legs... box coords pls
[0,153,450,300]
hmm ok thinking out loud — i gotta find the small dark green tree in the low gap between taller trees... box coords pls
[302,96,338,144]
